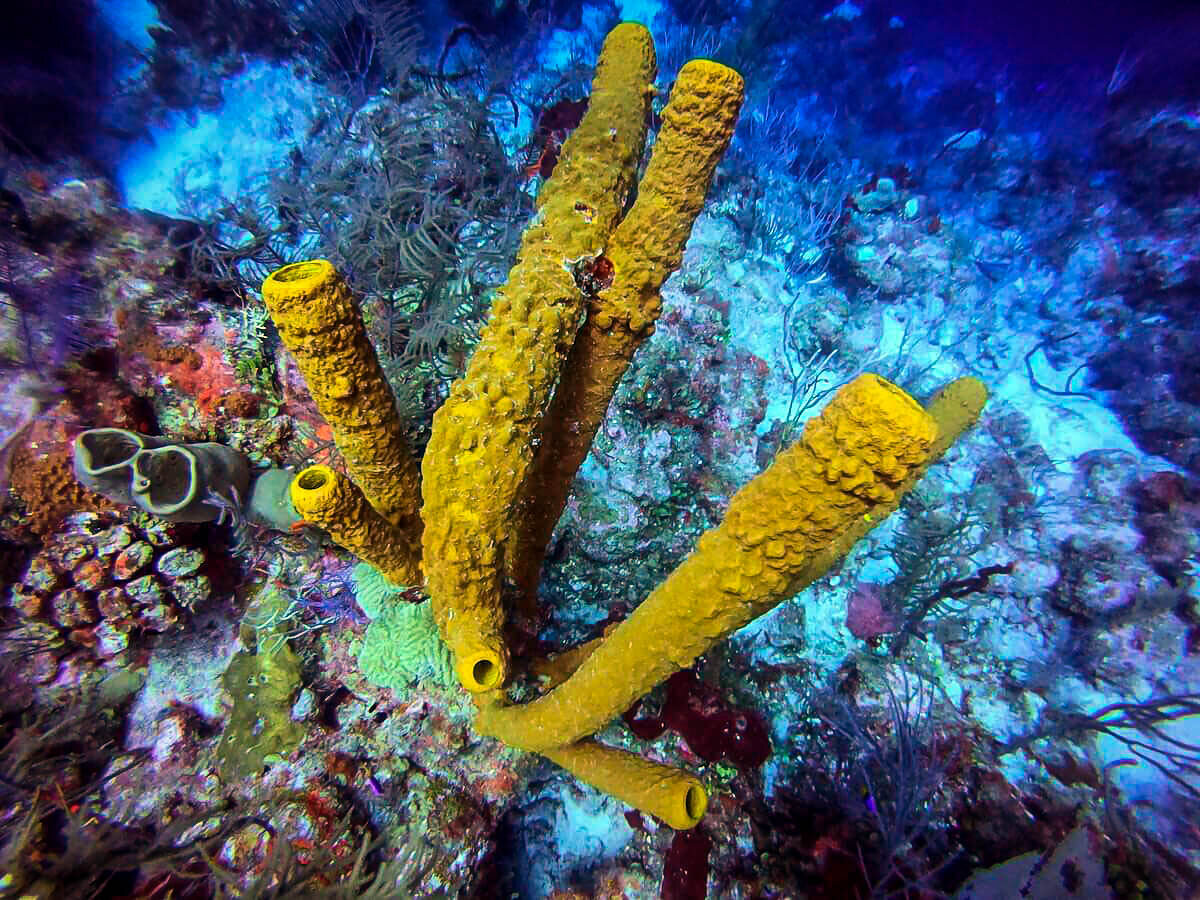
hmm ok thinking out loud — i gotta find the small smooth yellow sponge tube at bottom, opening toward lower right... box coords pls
[541,740,708,830]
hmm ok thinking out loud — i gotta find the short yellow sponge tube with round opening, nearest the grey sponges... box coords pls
[289,466,421,587]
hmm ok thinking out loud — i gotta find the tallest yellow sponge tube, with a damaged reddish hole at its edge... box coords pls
[421,24,655,692]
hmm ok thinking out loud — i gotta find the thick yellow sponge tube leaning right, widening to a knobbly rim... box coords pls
[475,376,938,752]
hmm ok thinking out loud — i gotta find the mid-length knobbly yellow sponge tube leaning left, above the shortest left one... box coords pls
[263,259,421,538]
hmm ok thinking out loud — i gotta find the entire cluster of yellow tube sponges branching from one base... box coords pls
[263,23,986,828]
